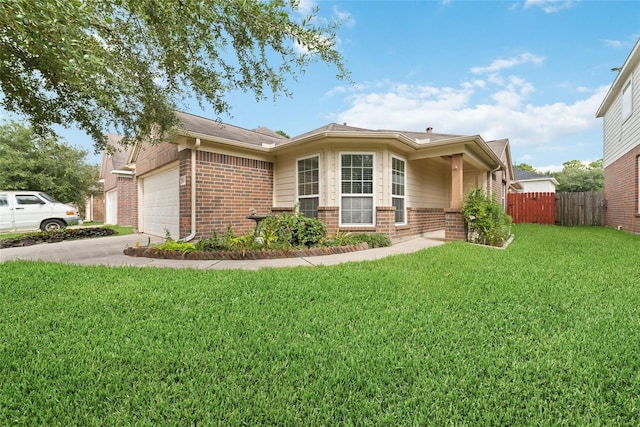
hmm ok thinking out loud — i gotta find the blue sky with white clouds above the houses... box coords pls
[5,0,640,171]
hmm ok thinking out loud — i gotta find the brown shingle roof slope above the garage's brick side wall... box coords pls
[176,111,287,146]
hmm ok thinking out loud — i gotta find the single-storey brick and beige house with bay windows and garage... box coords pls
[102,113,514,240]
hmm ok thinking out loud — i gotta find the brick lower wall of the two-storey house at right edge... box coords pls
[604,145,640,233]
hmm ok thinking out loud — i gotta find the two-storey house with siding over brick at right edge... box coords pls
[596,40,640,233]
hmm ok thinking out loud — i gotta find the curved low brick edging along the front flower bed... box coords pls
[123,243,369,260]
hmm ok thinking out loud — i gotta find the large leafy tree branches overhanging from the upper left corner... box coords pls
[0,0,348,149]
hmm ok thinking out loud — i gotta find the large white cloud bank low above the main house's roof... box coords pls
[332,79,608,153]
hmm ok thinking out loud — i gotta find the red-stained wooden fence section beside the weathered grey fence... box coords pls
[507,193,556,224]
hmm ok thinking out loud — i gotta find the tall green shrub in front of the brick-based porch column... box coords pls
[462,187,512,246]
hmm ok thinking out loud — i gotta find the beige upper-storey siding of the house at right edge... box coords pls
[604,67,640,167]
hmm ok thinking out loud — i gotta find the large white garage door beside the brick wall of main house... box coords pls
[141,168,180,240]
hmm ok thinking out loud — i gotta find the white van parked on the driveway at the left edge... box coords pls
[0,191,82,232]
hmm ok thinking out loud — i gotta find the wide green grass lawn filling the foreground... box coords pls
[0,225,640,426]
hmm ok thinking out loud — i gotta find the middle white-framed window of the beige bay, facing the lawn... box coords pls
[340,154,373,225]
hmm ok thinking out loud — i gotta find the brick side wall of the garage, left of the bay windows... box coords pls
[188,150,273,237]
